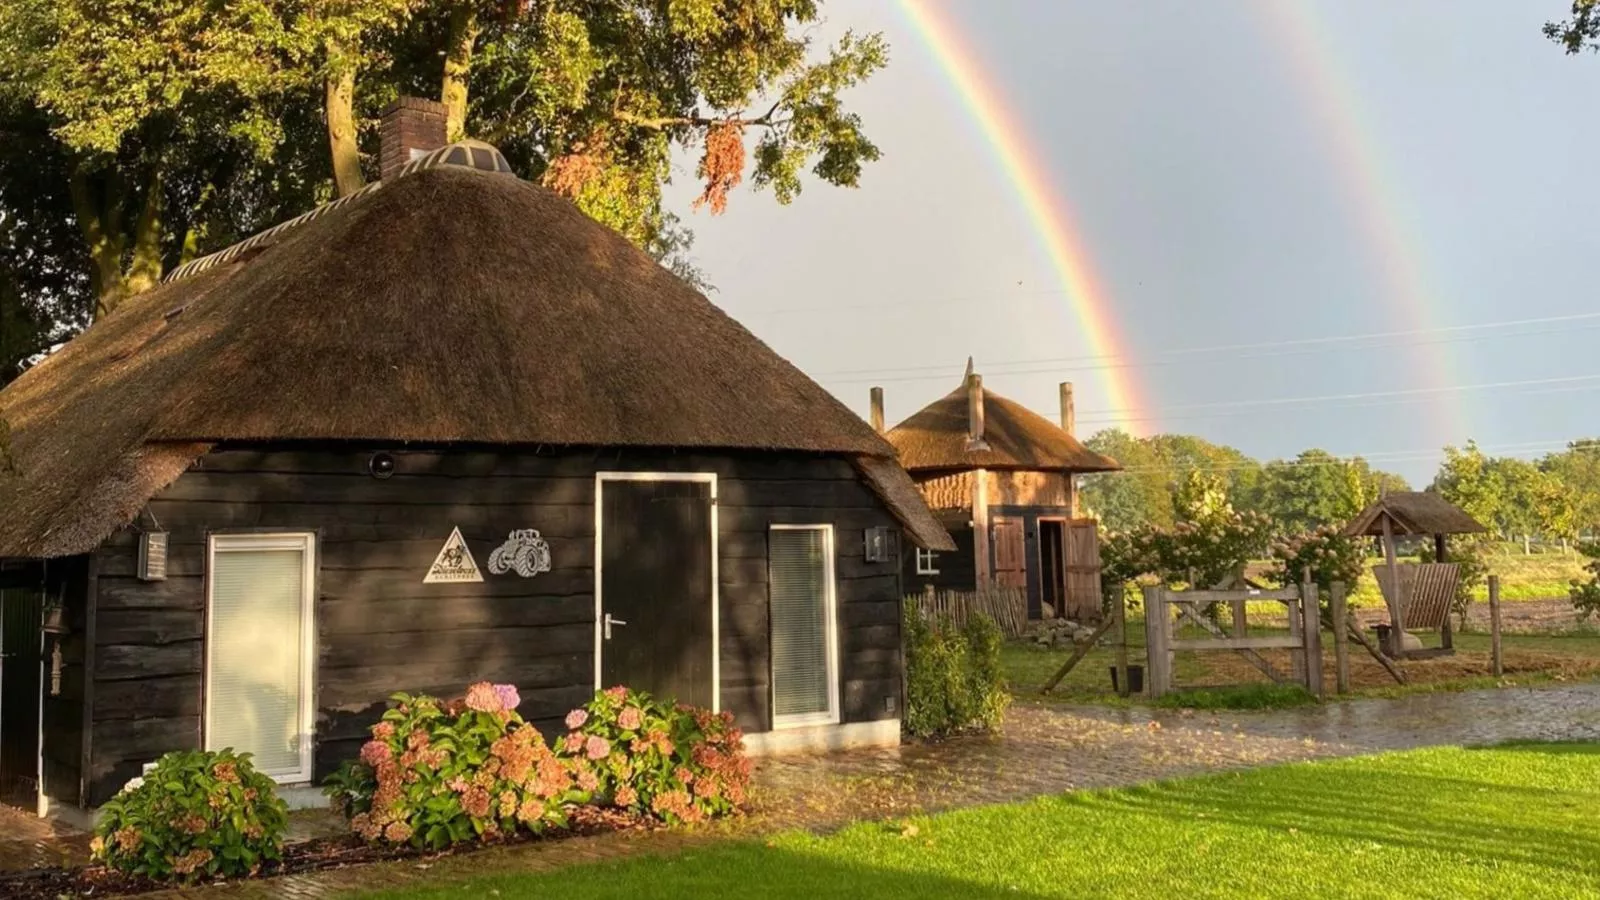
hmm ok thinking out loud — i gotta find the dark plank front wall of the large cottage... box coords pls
[78,447,901,806]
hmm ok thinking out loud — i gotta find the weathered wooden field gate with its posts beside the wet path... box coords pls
[1144,586,1322,698]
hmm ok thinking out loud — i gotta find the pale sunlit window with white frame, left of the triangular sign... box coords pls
[205,533,315,785]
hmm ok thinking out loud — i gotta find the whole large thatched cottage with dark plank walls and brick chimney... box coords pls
[0,101,954,807]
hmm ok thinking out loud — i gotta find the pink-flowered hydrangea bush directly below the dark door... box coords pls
[558,685,750,823]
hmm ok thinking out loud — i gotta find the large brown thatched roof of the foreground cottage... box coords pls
[0,148,949,557]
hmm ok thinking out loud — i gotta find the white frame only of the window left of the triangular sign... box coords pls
[202,532,317,785]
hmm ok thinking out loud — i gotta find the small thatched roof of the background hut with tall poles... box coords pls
[886,383,1122,472]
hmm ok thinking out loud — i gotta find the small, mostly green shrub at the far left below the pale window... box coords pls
[91,749,288,881]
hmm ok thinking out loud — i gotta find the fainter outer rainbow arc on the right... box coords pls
[1254,0,1469,442]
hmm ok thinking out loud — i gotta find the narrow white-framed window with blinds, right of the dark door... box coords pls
[768,525,838,729]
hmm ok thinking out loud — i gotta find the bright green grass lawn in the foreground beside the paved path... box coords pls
[350,745,1600,900]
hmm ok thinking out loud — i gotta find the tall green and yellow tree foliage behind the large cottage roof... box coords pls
[0,0,888,360]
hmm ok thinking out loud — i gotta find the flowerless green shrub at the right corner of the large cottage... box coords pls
[906,604,1011,737]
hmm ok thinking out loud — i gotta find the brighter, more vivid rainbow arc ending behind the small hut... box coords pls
[898,0,1152,431]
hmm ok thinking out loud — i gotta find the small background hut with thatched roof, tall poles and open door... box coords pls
[872,360,1122,621]
